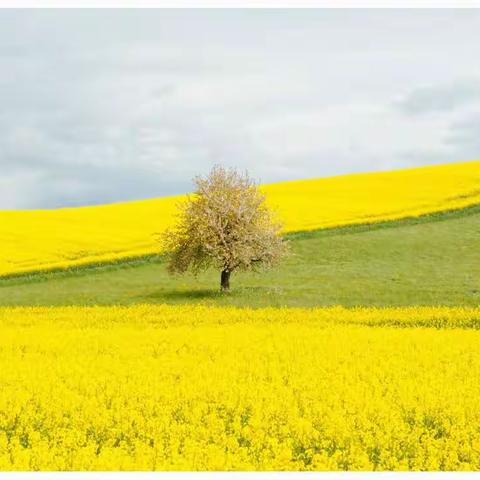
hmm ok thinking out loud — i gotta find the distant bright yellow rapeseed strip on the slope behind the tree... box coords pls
[0,161,480,275]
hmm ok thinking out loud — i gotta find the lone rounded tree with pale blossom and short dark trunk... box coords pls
[161,166,287,291]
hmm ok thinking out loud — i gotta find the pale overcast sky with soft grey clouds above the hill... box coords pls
[0,9,480,209]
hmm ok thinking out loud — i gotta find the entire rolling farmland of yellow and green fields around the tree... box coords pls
[0,162,480,471]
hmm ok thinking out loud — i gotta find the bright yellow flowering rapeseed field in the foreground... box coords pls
[0,306,480,470]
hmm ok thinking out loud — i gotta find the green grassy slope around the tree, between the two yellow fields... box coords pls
[0,206,480,307]
